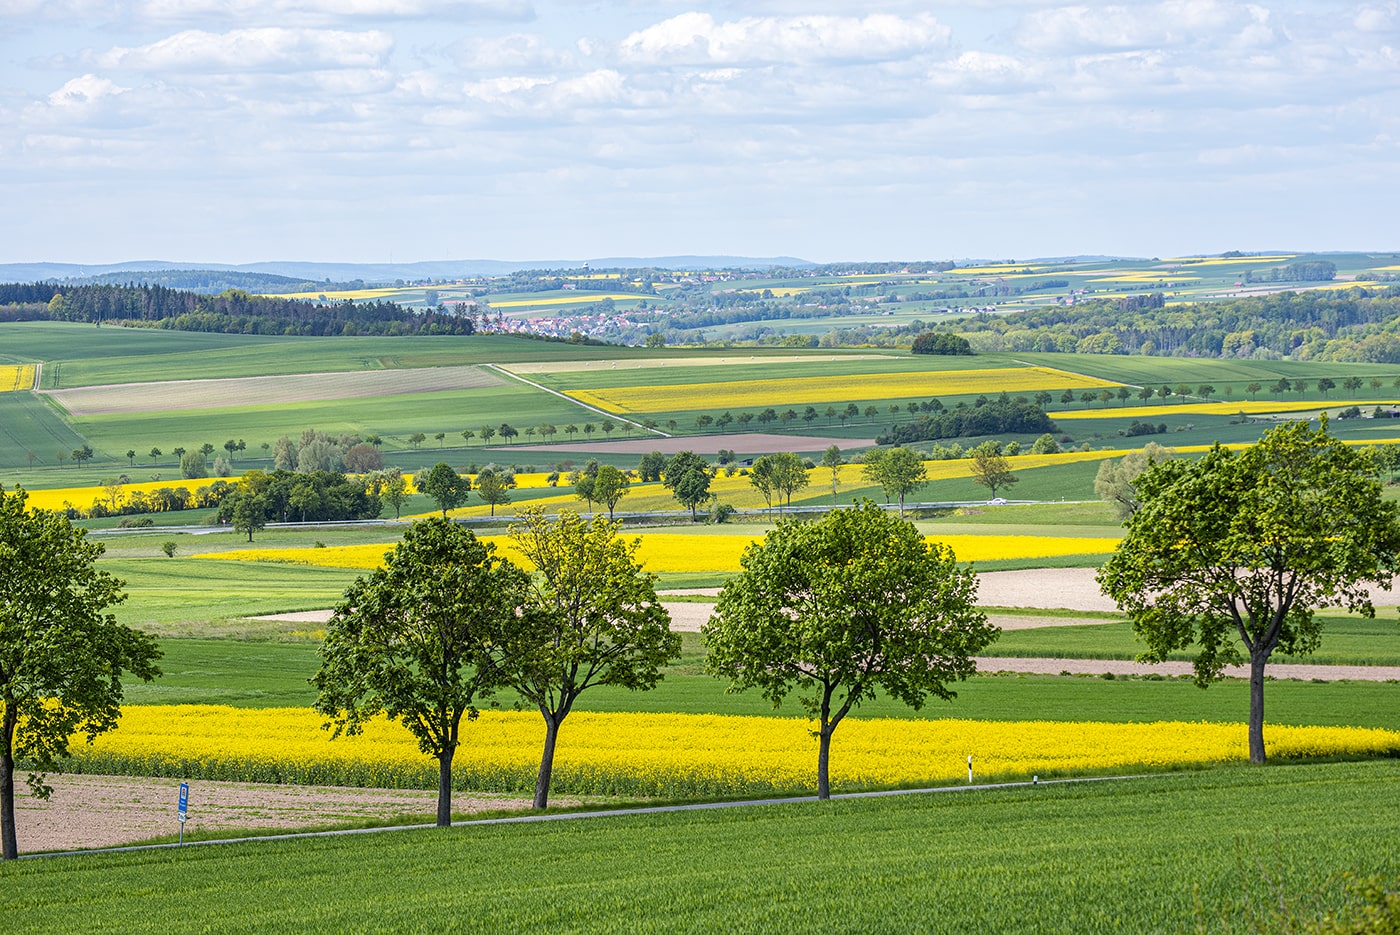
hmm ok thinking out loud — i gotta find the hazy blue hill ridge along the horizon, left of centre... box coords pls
[0,256,815,285]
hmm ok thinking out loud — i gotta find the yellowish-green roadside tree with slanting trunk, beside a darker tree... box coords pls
[493,508,680,809]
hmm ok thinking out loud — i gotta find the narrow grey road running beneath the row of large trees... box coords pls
[18,773,1153,861]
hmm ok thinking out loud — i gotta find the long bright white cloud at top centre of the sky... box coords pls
[620,13,949,64]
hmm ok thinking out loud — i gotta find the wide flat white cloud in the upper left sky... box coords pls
[92,28,393,73]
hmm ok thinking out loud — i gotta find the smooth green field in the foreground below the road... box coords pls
[0,761,1400,934]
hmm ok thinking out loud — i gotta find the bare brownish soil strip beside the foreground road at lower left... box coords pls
[15,774,562,854]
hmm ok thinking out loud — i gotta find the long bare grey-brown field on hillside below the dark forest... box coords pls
[46,367,503,416]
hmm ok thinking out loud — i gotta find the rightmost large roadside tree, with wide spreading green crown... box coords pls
[1099,421,1400,763]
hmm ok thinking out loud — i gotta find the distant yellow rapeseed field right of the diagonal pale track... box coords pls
[568,367,1119,413]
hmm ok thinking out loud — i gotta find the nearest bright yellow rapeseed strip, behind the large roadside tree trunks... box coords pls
[60,705,1400,795]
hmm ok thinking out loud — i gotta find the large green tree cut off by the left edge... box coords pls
[0,487,161,859]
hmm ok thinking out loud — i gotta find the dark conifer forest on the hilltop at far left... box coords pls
[0,283,476,336]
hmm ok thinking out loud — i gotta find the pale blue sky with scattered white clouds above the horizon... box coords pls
[0,0,1400,265]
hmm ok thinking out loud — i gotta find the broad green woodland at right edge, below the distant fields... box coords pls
[938,287,1400,364]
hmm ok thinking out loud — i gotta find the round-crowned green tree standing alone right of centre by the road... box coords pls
[701,500,1000,799]
